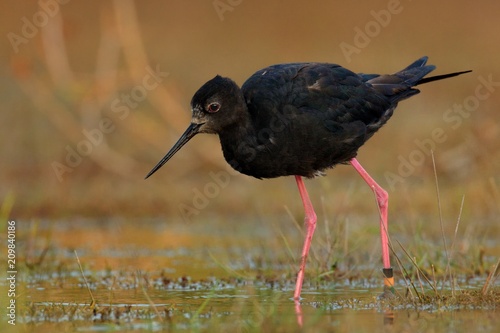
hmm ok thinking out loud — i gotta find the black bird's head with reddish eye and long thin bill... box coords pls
[146,75,246,178]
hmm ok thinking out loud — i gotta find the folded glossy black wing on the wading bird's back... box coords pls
[242,63,393,133]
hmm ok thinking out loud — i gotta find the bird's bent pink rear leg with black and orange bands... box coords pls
[350,158,394,288]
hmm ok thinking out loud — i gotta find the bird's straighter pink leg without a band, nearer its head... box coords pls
[293,176,316,300]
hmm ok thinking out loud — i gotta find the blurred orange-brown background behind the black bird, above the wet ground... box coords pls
[0,0,500,227]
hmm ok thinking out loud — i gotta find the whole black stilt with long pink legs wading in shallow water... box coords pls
[146,57,469,300]
